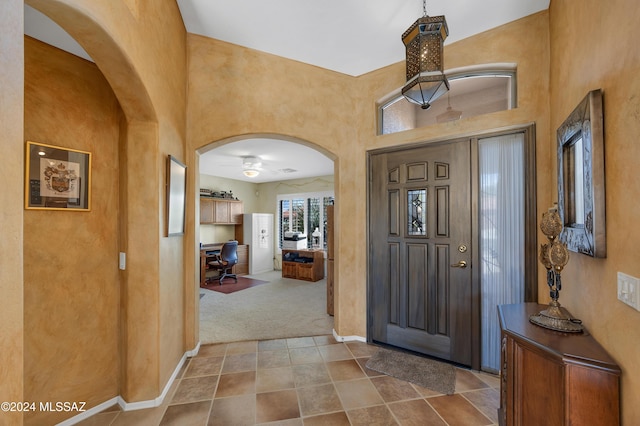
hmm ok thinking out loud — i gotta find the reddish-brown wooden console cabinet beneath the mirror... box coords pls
[498,303,620,426]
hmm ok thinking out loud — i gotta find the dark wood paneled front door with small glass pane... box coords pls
[368,139,477,366]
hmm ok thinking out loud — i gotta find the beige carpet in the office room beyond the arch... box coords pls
[199,271,333,344]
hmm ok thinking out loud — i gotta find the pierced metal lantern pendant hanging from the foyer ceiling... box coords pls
[402,0,449,109]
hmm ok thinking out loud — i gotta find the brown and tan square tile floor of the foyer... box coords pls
[81,336,500,426]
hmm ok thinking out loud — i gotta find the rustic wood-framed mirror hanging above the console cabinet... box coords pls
[557,89,607,257]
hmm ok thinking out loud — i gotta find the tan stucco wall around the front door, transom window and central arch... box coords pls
[188,12,551,337]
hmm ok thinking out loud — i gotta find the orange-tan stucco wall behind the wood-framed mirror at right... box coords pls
[552,0,640,425]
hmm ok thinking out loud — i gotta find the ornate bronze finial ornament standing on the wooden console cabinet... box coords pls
[529,206,583,333]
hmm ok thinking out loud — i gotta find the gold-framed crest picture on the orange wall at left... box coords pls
[24,141,91,212]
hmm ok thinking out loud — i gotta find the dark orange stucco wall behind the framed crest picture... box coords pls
[23,37,122,425]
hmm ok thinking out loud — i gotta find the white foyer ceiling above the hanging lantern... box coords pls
[177,0,549,76]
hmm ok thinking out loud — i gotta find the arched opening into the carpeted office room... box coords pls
[196,135,335,344]
